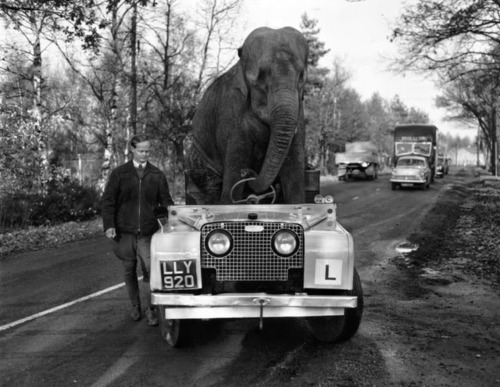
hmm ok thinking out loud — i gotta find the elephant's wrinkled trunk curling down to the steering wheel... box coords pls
[249,89,300,193]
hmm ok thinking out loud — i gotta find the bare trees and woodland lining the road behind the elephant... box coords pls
[0,0,497,233]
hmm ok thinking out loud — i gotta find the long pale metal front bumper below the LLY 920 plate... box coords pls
[151,292,358,320]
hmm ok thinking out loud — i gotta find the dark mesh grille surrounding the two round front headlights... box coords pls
[201,221,304,281]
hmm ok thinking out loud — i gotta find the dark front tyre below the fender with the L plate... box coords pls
[306,269,363,343]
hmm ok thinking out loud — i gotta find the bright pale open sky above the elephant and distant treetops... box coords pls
[232,0,476,138]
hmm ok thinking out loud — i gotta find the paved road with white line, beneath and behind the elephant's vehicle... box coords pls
[0,176,450,386]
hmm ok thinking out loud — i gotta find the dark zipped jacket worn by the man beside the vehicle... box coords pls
[102,160,174,236]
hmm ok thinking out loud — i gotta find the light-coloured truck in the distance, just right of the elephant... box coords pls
[335,141,379,180]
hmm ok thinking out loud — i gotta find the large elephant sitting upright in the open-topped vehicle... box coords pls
[187,27,309,204]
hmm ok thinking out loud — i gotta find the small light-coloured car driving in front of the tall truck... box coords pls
[391,156,431,190]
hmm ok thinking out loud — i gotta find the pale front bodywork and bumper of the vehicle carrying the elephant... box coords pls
[150,204,357,319]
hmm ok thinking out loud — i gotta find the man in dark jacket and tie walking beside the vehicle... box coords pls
[102,135,174,326]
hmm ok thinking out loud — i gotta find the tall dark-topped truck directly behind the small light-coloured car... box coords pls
[393,124,438,182]
